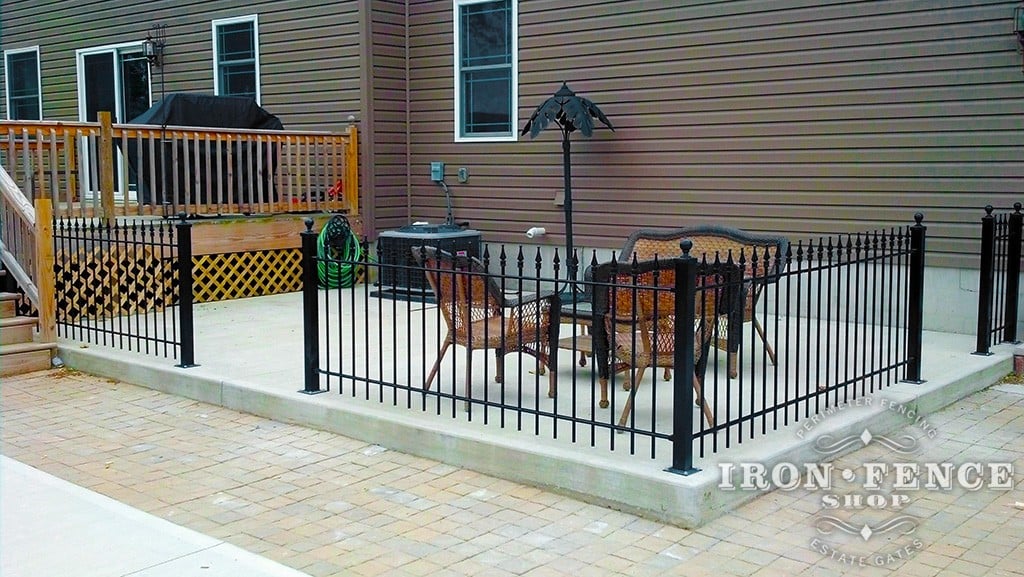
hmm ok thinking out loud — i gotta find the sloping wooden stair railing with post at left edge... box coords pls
[0,166,56,342]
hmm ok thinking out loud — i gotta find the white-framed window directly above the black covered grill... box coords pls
[213,15,260,102]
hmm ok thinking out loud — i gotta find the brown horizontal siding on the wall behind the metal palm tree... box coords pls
[395,0,1024,267]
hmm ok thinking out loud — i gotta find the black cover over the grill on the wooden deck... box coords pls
[126,93,284,209]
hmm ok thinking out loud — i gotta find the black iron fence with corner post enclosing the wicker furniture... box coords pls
[303,214,926,472]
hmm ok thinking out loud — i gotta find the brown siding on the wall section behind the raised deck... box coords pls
[0,0,361,130]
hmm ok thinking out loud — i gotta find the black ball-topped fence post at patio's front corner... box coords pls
[666,239,700,476]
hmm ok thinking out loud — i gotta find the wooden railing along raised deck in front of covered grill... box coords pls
[0,113,359,217]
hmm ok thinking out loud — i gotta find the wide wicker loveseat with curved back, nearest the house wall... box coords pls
[618,224,790,378]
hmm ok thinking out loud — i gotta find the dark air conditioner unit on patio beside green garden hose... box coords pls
[377,224,481,294]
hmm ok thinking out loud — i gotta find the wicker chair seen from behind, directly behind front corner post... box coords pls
[594,258,741,426]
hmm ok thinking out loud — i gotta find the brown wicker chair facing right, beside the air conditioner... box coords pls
[412,246,558,399]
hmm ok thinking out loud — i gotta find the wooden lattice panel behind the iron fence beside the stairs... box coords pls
[55,247,177,323]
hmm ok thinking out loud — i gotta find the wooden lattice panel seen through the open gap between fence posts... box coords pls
[193,248,302,302]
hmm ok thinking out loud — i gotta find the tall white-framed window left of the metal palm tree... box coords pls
[454,0,518,141]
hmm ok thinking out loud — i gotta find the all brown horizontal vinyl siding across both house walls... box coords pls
[0,0,1024,267]
